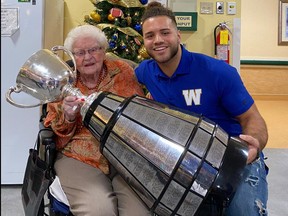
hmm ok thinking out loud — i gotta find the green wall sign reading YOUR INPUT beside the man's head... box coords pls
[174,12,197,31]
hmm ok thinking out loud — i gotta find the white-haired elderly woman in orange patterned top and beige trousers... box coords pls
[44,25,150,216]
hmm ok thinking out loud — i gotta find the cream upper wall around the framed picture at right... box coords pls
[241,0,288,61]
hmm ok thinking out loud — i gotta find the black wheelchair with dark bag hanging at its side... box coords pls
[21,104,73,216]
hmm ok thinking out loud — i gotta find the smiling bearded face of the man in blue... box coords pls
[142,16,180,63]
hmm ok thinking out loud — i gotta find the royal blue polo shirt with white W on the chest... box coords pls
[135,47,254,136]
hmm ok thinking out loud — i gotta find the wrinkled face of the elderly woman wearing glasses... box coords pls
[72,37,105,76]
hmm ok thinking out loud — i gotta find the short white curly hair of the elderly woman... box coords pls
[64,24,108,51]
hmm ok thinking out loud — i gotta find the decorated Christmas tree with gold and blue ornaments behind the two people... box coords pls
[84,0,149,63]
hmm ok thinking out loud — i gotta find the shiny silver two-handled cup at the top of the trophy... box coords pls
[6,46,76,108]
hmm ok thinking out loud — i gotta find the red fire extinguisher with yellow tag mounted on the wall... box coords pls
[214,22,231,64]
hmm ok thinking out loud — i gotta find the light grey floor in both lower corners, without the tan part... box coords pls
[1,148,288,216]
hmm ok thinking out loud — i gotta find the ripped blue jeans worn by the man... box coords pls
[225,154,268,216]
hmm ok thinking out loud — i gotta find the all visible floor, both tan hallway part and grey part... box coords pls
[1,100,288,216]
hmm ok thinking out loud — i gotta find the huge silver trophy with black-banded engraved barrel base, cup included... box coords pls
[7,47,248,216]
